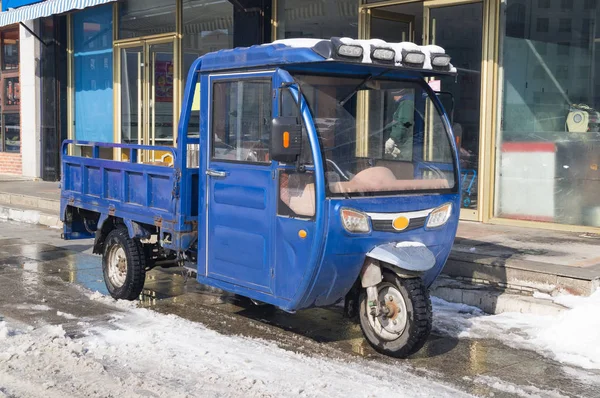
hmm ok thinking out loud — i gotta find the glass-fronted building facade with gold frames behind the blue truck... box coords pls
[0,0,600,232]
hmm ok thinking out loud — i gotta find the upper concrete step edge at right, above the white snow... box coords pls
[443,247,600,296]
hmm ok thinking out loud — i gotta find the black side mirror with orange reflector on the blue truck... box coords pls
[270,116,302,163]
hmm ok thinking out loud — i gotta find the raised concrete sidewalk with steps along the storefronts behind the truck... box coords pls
[0,176,600,313]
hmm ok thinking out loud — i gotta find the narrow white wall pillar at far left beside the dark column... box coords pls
[19,21,42,178]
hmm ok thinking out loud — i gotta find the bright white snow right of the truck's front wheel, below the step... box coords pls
[433,290,600,369]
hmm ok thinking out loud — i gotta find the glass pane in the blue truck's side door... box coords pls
[212,79,272,163]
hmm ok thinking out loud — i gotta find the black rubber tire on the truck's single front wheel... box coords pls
[359,272,432,358]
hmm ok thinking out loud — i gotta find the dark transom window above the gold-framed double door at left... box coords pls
[119,0,177,39]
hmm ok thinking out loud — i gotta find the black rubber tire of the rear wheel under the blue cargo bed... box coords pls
[102,227,146,300]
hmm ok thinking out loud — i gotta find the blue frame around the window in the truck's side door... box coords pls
[209,73,274,166]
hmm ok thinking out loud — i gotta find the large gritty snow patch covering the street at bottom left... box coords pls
[0,295,465,398]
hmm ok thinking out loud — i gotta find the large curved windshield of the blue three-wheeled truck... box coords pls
[294,75,456,197]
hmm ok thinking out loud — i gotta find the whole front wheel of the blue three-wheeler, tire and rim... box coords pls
[359,272,431,358]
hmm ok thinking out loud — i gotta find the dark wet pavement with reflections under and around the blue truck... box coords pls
[0,223,600,397]
